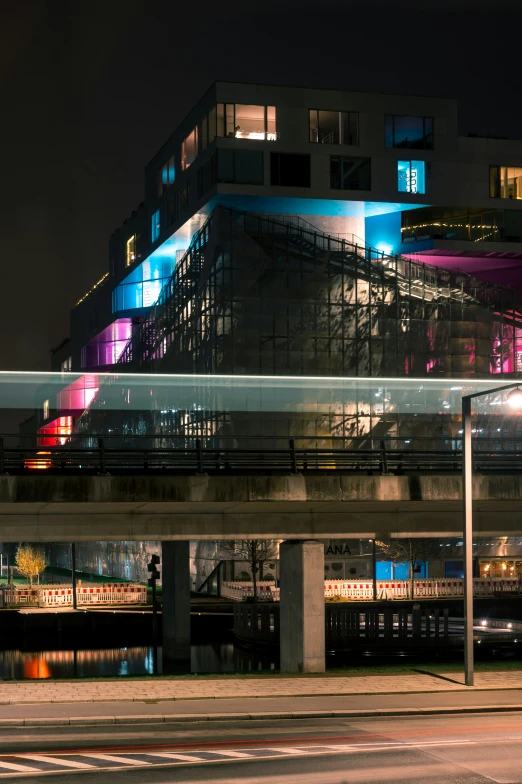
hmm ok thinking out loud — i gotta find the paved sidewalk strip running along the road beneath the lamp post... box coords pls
[0,672,522,727]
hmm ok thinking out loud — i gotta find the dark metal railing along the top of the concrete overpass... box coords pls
[0,434,522,474]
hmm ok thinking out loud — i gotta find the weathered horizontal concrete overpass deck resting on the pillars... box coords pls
[0,473,522,542]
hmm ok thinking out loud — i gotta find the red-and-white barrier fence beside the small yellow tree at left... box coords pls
[0,583,147,607]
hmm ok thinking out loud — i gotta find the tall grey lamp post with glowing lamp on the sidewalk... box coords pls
[462,382,522,686]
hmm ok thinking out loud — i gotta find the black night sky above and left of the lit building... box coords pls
[0,0,522,370]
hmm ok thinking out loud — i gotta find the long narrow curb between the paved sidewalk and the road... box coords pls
[0,704,522,728]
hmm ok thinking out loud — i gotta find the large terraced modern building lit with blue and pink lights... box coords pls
[28,82,522,584]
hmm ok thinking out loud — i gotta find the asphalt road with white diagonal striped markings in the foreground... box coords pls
[0,712,522,784]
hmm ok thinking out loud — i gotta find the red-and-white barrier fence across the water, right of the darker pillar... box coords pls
[221,578,522,602]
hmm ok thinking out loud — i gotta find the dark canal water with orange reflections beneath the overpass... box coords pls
[0,642,279,680]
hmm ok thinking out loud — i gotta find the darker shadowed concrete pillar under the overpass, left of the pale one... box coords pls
[161,542,190,669]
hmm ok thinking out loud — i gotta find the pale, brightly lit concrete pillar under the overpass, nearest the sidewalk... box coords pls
[279,541,325,672]
